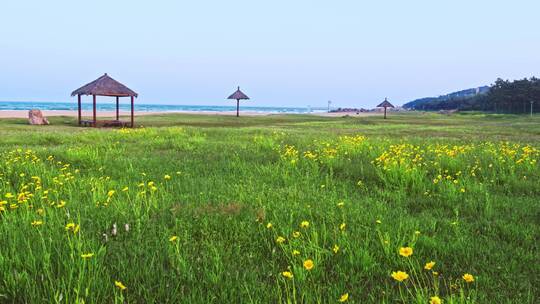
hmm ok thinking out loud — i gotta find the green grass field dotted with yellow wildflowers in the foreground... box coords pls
[0,113,540,303]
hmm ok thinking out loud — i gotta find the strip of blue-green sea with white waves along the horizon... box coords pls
[0,101,326,114]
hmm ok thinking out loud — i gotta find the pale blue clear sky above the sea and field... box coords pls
[0,0,540,108]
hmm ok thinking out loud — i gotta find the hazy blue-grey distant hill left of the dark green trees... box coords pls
[403,86,490,111]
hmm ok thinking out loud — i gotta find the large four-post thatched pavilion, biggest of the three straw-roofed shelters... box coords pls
[71,73,139,128]
